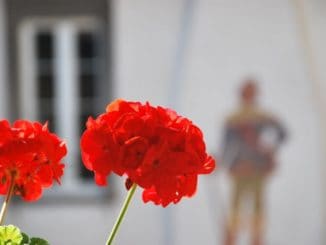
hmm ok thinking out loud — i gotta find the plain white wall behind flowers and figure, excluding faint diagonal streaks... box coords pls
[0,0,326,245]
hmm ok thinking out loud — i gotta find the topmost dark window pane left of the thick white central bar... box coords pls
[36,32,53,59]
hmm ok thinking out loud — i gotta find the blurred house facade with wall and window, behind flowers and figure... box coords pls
[0,0,326,245]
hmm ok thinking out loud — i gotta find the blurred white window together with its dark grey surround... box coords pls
[6,0,111,199]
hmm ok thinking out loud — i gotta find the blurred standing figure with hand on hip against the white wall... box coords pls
[222,79,285,245]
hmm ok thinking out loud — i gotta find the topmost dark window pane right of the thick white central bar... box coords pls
[78,32,96,58]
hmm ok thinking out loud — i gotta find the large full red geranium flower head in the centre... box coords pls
[81,100,215,206]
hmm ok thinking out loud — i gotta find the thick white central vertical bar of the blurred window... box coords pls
[54,22,79,188]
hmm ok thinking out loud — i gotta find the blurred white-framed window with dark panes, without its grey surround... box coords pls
[18,18,109,199]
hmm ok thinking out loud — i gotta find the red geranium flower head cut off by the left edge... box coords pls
[0,120,67,201]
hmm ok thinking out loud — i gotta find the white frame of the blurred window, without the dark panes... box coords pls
[17,17,111,201]
